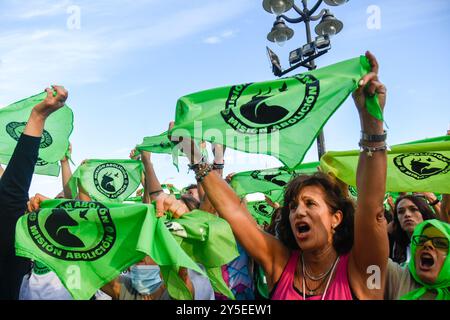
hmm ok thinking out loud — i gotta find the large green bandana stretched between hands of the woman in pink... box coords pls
[171,56,379,168]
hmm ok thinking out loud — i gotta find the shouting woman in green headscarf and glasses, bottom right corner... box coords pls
[385,219,450,300]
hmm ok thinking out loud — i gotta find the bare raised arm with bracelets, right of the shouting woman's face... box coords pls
[349,52,389,299]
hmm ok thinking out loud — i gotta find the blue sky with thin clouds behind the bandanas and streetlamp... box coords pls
[0,0,450,196]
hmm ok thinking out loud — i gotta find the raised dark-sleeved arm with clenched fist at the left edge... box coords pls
[0,86,68,300]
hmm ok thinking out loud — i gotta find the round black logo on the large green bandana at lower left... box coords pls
[27,201,116,261]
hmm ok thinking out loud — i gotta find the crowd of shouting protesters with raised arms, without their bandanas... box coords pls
[0,53,450,300]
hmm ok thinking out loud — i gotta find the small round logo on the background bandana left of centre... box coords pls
[94,163,129,199]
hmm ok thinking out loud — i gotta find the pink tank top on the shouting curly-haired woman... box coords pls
[272,251,353,300]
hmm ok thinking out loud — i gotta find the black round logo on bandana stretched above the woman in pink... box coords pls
[221,74,320,134]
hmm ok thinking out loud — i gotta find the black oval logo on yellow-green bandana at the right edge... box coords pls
[394,152,450,180]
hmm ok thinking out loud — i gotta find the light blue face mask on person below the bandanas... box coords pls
[130,265,162,295]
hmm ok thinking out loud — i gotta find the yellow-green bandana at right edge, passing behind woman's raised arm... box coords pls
[320,138,450,194]
